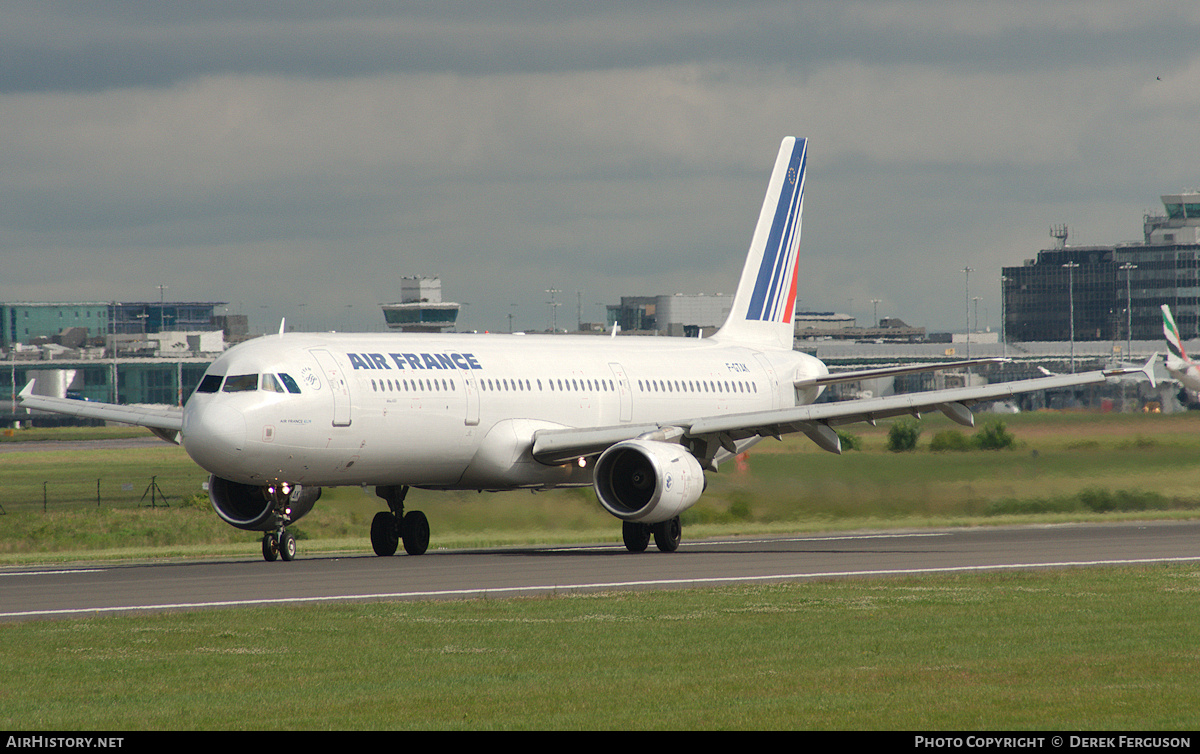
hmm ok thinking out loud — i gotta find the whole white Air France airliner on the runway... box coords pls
[22,137,1137,561]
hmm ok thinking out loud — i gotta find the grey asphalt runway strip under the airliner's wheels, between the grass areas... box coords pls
[0,521,1200,621]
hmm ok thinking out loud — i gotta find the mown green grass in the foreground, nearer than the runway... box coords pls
[0,566,1200,731]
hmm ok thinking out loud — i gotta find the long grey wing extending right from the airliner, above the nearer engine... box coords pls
[532,369,1142,465]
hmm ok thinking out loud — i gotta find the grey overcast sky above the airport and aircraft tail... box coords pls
[0,0,1200,330]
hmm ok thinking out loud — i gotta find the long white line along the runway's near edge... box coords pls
[9,556,1200,618]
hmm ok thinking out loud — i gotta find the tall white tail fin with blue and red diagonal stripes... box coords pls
[713,137,808,351]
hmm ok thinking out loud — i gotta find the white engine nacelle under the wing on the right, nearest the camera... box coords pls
[593,439,704,523]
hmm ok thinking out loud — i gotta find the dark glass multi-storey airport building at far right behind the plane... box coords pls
[1001,192,1200,342]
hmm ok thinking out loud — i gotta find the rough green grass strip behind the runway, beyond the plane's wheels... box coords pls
[0,412,1200,562]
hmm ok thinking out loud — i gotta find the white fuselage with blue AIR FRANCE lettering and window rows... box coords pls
[182,334,827,489]
